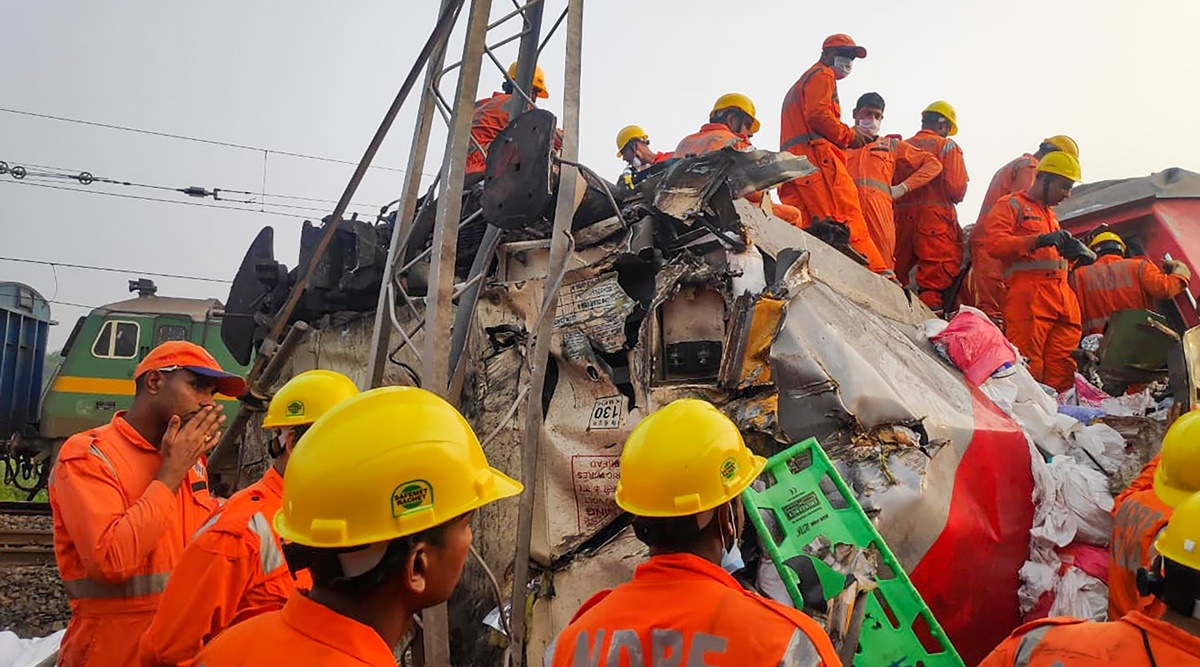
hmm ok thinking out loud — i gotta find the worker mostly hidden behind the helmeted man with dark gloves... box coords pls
[962,134,1079,329]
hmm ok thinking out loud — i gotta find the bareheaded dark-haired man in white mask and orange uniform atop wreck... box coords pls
[846,92,942,269]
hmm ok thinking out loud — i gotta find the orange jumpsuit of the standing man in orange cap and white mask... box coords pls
[779,62,888,274]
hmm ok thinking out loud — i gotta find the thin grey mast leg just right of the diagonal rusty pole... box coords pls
[362,0,462,389]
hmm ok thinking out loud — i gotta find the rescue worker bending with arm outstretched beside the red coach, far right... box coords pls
[1067,232,1192,336]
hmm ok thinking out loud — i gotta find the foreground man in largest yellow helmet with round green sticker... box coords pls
[193,386,523,667]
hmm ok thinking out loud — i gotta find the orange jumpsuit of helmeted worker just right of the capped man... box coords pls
[142,468,312,666]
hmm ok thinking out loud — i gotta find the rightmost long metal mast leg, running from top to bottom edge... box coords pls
[509,0,583,662]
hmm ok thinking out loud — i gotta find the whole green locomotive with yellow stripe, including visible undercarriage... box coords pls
[2,278,246,499]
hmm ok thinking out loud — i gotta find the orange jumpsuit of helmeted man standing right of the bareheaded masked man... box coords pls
[895,130,968,311]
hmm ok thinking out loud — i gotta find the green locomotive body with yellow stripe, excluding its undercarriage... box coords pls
[38,313,246,439]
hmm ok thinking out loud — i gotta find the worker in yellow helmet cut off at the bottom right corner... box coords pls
[979,487,1200,667]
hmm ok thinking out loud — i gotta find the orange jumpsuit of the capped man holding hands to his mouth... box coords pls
[49,411,216,667]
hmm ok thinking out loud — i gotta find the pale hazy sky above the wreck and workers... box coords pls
[0,0,1200,348]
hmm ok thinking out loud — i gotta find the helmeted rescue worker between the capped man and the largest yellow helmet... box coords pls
[140,371,359,666]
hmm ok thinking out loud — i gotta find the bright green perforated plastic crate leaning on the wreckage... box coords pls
[742,438,964,667]
